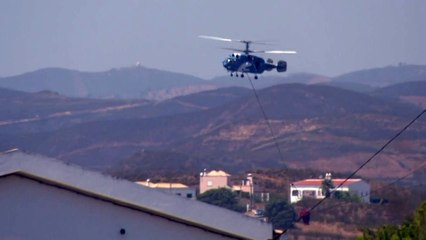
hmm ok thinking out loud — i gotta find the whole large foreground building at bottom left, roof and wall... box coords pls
[0,152,272,240]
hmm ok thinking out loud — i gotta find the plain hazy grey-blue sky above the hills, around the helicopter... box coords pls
[0,0,426,79]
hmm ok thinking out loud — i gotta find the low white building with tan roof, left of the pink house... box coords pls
[136,179,196,200]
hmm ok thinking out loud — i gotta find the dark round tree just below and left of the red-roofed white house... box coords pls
[265,200,297,229]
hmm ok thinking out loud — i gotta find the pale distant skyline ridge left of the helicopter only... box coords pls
[0,66,213,99]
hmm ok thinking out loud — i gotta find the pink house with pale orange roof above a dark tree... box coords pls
[200,169,231,194]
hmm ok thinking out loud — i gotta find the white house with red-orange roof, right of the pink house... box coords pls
[290,174,370,203]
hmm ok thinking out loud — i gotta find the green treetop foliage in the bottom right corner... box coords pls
[358,201,426,240]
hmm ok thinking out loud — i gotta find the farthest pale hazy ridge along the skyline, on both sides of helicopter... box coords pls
[0,65,426,101]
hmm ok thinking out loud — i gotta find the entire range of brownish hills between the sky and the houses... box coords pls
[0,66,426,182]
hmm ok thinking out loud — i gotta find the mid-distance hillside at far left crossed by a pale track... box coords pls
[0,88,154,135]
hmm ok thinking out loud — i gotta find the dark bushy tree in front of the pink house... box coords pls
[197,188,245,212]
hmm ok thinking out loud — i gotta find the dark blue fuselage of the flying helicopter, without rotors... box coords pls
[223,53,276,74]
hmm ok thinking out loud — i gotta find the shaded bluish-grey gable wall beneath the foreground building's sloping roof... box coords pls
[0,175,236,240]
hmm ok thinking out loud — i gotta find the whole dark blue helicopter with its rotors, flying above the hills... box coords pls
[198,35,296,79]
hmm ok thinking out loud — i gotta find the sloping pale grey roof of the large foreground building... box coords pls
[0,152,272,240]
